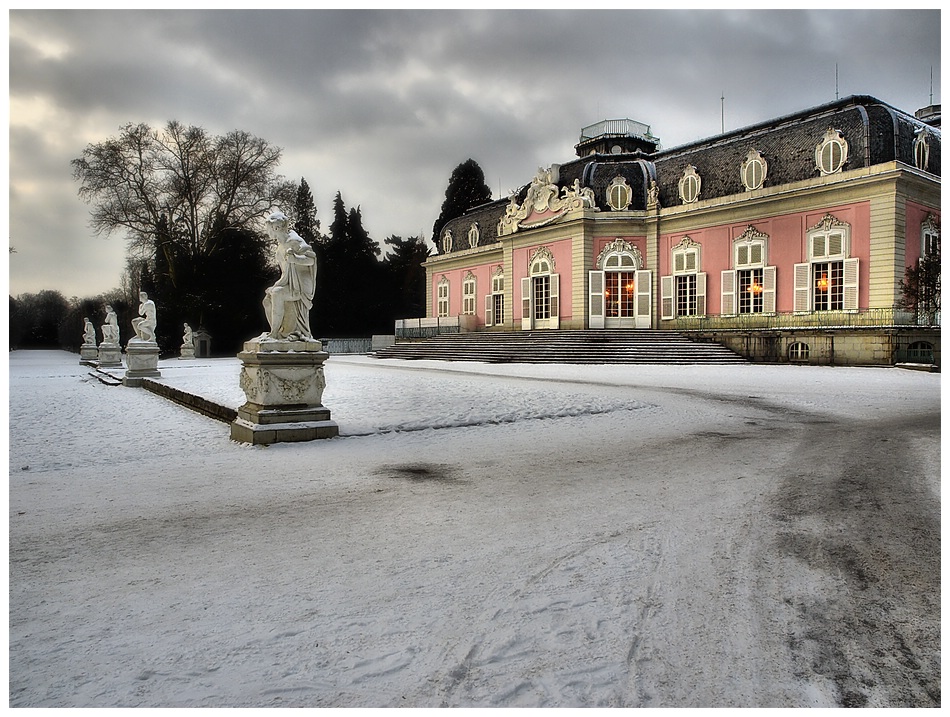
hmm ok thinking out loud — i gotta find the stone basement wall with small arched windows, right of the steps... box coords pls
[683,326,940,366]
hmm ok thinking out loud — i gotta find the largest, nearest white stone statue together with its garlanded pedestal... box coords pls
[231,211,339,444]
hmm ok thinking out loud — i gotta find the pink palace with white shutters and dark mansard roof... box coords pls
[418,96,940,364]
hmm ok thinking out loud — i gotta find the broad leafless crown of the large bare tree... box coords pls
[72,121,296,259]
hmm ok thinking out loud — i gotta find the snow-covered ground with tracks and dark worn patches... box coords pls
[9,352,940,707]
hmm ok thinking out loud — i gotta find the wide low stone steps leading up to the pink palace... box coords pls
[375,329,747,364]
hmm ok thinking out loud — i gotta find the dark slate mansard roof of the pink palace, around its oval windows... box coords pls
[435,96,940,252]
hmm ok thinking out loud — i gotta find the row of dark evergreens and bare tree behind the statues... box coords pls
[10,121,491,355]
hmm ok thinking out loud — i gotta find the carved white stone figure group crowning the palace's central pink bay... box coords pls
[498,164,597,236]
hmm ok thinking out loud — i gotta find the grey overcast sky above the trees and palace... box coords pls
[8,5,940,298]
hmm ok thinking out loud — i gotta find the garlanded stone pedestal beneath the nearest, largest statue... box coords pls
[231,339,339,444]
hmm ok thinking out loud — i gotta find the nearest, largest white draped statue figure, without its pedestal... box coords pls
[261,212,317,341]
